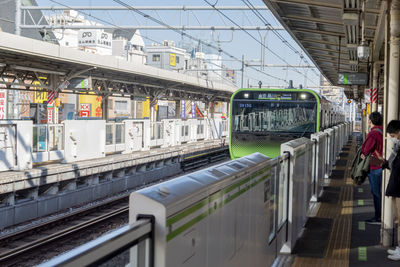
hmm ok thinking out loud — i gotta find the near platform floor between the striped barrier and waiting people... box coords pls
[292,135,400,267]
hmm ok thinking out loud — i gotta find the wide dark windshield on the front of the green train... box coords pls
[232,91,317,136]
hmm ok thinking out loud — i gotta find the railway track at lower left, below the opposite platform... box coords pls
[0,196,129,266]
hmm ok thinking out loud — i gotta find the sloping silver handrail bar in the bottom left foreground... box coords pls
[39,219,153,267]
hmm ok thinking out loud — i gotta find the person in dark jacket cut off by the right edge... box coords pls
[385,120,400,261]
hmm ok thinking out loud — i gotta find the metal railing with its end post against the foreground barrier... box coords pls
[39,218,154,267]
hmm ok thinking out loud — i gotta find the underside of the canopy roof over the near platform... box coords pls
[264,0,382,98]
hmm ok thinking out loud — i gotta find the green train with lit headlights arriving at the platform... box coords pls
[229,88,345,159]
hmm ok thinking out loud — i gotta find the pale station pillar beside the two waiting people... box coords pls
[382,0,400,246]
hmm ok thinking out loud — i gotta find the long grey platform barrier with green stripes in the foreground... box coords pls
[43,123,352,267]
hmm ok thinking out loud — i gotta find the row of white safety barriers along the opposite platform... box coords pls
[0,119,228,171]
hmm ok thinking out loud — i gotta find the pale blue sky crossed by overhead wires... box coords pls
[37,0,320,88]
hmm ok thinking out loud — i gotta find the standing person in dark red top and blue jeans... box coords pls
[361,111,383,224]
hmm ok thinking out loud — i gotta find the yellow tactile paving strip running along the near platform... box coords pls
[292,137,356,267]
